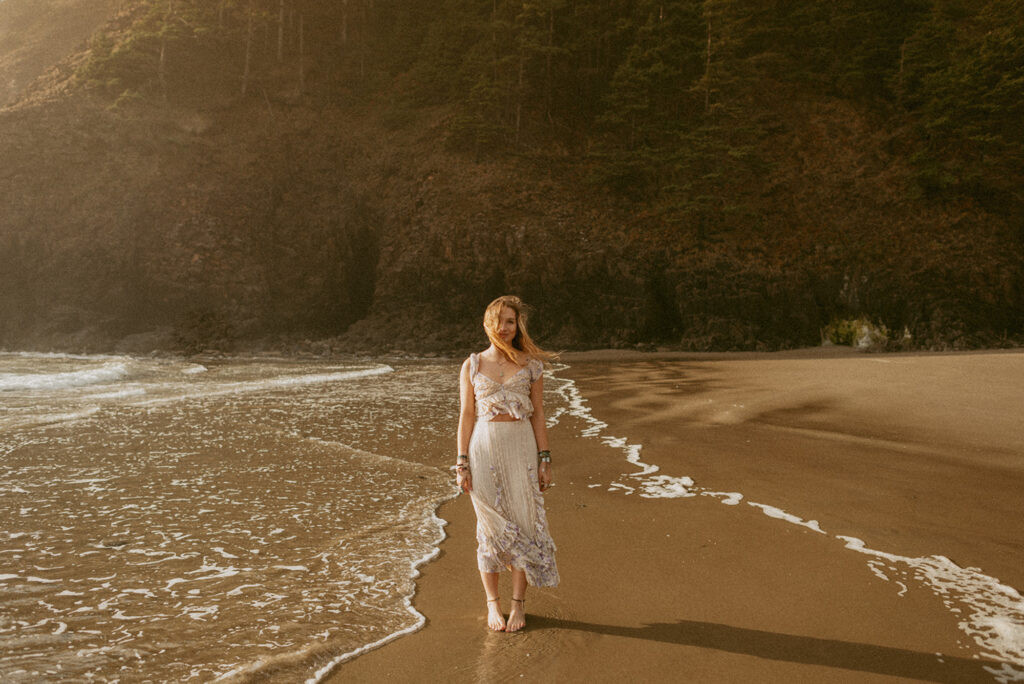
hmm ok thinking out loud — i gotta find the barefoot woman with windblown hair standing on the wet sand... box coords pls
[456,296,558,632]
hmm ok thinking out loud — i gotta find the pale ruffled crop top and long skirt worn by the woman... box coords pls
[469,354,558,587]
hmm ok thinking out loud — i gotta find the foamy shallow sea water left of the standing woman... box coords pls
[0,354,458,681]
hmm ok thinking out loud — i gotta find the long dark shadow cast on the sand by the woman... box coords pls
[529,615,1002,684]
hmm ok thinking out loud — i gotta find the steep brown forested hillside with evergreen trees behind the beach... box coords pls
[0,0,1024,351]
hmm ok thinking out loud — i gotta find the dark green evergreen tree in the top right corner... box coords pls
[903,0,1024,212]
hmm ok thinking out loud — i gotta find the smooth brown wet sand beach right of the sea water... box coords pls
[333,348,1024,682]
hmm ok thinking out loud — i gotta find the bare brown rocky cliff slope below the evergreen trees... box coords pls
[0,0,1024,352]
